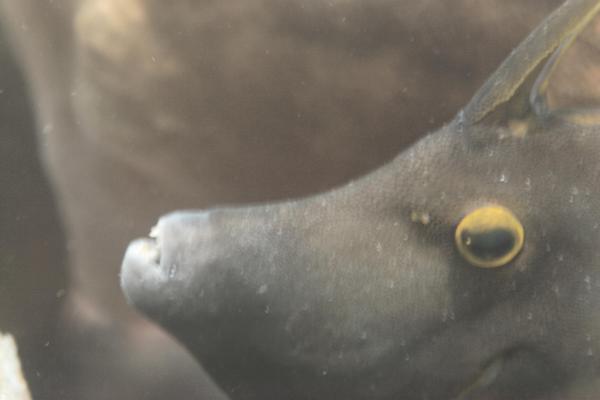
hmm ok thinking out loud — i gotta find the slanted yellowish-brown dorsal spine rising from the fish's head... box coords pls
[458,0,600,125]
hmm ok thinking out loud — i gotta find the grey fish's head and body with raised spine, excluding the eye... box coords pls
[121,0,600,400]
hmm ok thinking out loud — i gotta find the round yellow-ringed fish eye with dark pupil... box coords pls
[454,205,525,268]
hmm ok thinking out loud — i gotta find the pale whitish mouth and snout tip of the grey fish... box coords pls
[120,211,223,321]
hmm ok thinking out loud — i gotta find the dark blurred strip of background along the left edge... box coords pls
[0,18,66,390]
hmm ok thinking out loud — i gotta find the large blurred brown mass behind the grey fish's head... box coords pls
[0,0,583,400]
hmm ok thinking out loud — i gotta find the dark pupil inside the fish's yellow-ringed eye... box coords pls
[460,229,515,260]
